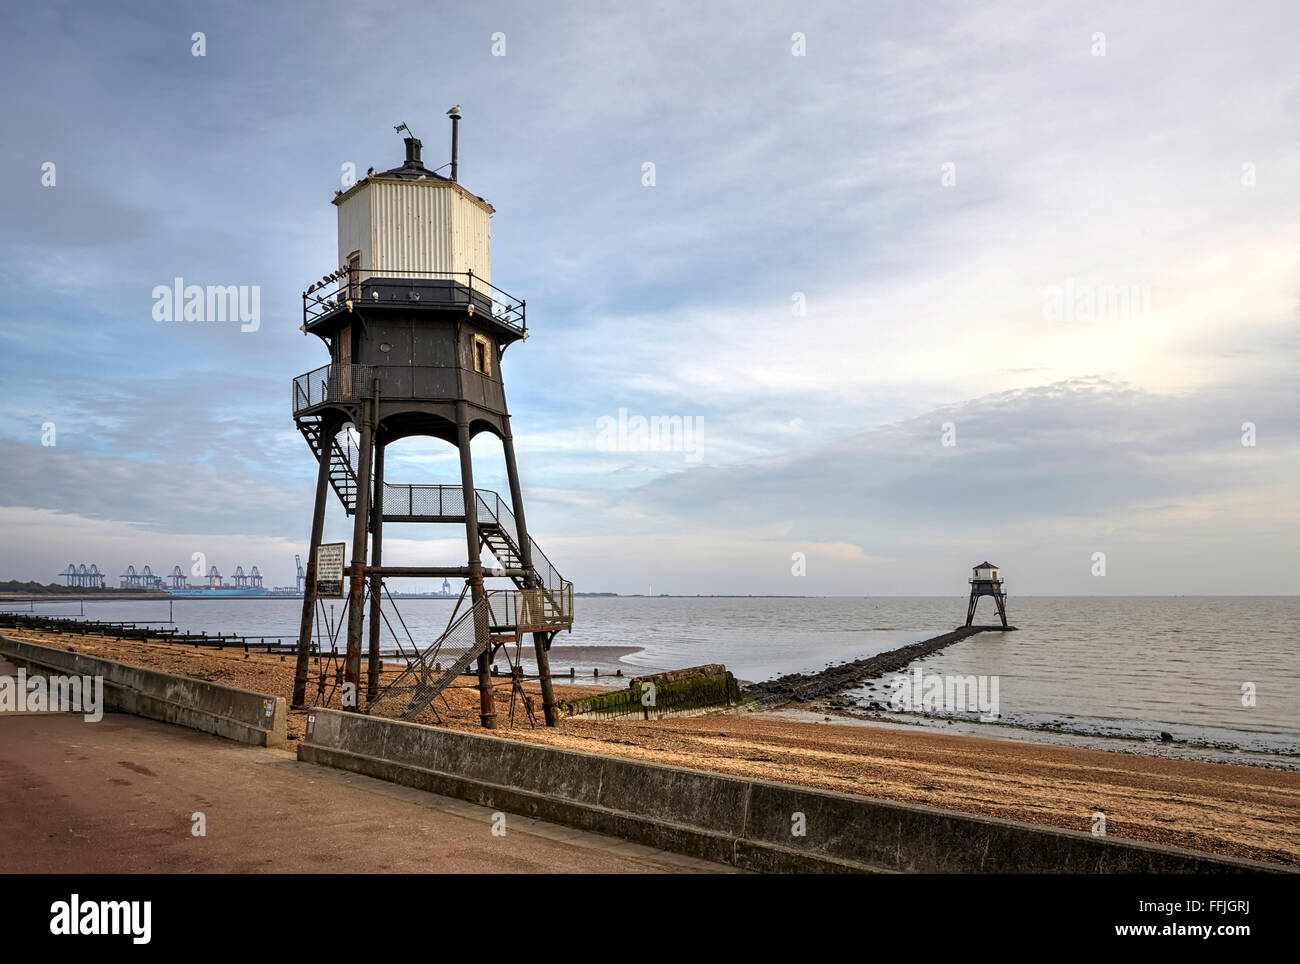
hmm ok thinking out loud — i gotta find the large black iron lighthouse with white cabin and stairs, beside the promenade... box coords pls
[293,110,573,728]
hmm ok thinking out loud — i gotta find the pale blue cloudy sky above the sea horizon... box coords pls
[0,0,1300,595]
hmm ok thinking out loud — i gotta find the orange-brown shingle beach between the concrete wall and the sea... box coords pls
[5,629,1300,865]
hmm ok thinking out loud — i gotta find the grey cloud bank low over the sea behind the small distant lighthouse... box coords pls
[527,378,1300,594]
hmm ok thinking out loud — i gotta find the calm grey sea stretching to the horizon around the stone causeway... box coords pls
[12,596,1300,755]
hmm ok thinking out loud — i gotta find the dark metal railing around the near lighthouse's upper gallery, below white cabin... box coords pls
[303,265,528,334]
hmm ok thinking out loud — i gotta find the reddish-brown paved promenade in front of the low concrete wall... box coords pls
[0,661,732,873]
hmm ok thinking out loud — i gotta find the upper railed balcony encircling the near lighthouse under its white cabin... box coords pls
[303,265,528,338]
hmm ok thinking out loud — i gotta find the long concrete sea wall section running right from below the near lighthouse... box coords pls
[298,709,1279,873]
